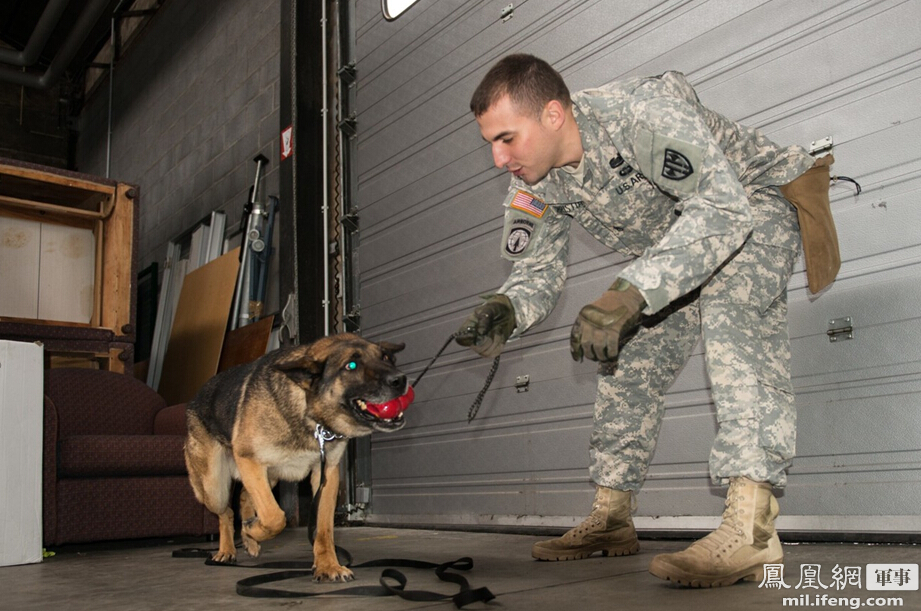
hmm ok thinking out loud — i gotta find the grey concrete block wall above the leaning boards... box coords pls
[77,0,281,269]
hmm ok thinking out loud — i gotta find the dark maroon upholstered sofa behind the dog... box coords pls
[42,369,217,546]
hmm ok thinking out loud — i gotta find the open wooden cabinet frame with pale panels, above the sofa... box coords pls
[0,158,138,371]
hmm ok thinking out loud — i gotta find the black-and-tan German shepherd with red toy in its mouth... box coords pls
[185,333,412,581]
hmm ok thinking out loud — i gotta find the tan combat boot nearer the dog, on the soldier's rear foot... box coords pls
[531,486,640,560]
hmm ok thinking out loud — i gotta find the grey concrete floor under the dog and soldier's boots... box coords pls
[7,527,921,611]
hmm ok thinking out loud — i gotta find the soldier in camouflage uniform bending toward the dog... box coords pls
[457,55,837,587]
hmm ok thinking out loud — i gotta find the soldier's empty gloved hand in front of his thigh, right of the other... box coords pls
[569,278,646,362]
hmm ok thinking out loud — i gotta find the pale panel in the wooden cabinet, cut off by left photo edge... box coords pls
[0,216,41,318]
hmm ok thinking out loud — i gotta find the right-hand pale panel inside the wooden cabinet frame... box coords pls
[38,223,96,324]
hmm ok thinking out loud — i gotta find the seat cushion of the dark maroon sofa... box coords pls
[58,435,187,477]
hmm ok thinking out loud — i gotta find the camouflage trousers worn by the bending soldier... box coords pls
[590,194,798,491]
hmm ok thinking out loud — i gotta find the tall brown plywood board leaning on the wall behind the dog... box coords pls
[157,249,240,405]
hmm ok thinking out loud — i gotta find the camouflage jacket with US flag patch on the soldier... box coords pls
[498,72,814,336]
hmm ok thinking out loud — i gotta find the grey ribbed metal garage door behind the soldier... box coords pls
[352,0,921,532]
